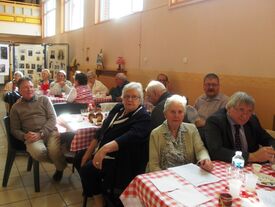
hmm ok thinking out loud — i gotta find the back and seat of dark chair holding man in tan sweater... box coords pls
[3,116,26,151]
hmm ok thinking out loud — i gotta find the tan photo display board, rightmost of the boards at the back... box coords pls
[46,44,69,77]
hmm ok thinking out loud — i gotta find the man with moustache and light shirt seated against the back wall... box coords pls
[194,73,228,126]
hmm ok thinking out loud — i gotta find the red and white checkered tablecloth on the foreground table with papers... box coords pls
[120,161,275,207]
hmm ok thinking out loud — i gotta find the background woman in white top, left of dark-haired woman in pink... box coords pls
[50,70,72,96]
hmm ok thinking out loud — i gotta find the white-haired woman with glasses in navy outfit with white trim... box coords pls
[76,82,150,207]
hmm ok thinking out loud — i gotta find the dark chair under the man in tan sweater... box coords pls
[2,116,40,192]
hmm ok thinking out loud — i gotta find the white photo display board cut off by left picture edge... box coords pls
[0,43,10,76]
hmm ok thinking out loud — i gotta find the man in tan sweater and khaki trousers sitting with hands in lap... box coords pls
[10,77,66,181]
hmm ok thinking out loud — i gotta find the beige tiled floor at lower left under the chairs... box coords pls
[0,90,93,207]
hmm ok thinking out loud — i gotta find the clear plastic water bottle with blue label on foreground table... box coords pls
[231,151,244,181]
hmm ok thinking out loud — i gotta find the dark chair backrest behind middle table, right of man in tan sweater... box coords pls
[53,103,88,116]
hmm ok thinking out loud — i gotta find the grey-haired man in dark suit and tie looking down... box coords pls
[205,92,275,162]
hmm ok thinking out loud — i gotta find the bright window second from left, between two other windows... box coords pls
[64,0,84,31]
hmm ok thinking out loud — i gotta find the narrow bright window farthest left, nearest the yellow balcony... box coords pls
[43,0,56,37]
